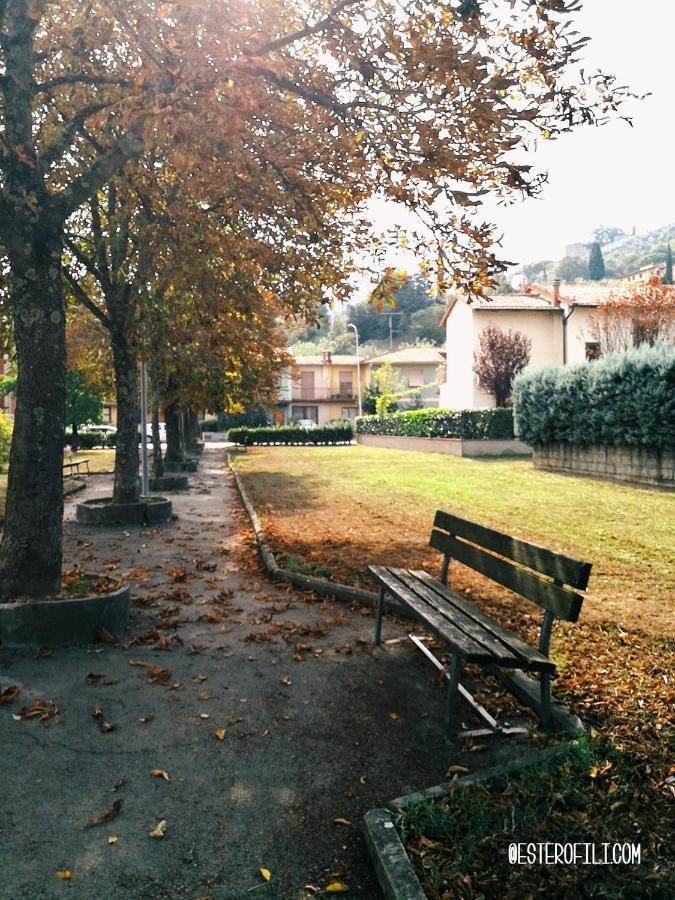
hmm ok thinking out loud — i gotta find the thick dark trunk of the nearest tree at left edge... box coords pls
[0,230,66,599]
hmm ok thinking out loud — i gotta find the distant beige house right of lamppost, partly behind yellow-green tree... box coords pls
[368,347,445,408]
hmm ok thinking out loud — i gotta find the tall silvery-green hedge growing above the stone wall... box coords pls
[513,344,675,448]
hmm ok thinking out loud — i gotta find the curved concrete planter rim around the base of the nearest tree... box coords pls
[0,576,130,648]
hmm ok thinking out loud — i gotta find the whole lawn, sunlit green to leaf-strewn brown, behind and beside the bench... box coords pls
[236,446,675,897]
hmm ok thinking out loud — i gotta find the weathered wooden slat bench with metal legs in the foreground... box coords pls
[368,510,591,737]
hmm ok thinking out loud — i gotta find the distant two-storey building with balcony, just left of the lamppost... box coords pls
[274,350,358,425]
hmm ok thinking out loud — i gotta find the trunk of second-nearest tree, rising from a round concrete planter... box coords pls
[112,326,141,503]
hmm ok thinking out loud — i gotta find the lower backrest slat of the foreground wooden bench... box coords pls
[429,529,583,622]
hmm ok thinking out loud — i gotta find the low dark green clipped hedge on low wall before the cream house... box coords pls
[356,409,513,440]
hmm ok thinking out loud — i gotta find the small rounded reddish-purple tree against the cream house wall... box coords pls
[473,325,532,406]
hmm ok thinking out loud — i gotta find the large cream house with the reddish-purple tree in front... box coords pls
[440,282,616,409]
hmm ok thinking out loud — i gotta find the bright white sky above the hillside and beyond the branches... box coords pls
[375,0,675,282]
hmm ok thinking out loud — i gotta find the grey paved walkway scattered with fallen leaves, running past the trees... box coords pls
[0,449,540,900]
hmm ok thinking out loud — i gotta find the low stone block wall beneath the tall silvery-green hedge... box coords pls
[532,444,675,490]
